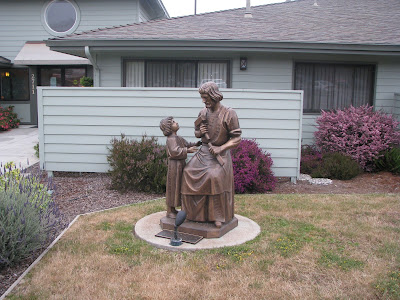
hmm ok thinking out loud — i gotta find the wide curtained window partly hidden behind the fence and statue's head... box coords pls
[124,60,229,88]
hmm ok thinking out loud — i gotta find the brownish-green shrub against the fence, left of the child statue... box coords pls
[107,134,168,193]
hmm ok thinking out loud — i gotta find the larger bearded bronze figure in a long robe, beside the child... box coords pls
[180,82,242,228]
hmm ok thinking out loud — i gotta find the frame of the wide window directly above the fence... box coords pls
[122,58,232,88]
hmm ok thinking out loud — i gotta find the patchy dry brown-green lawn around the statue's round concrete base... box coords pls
[7,194,400,299]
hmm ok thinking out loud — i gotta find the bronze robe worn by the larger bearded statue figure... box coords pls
[181,105,242,222]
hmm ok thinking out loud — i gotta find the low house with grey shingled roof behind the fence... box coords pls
[46,0,400,144]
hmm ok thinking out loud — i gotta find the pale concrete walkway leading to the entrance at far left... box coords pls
[0,125,39,168]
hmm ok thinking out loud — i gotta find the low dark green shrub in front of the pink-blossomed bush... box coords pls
[311,152,361,180]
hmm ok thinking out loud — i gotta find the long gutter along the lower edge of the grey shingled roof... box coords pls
[46,40,400,57]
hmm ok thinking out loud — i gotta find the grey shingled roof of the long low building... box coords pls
[53,0,400,46]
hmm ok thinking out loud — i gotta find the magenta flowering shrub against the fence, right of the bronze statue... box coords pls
[232,139,276,193]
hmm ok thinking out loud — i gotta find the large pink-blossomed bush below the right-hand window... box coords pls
[314,105,400,171]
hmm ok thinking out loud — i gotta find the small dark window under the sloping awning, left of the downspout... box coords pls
[38,66,86,86]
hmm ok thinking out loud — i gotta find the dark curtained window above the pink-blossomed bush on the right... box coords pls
[294,63,375,112]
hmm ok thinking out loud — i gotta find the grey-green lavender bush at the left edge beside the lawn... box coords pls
[0,165,63,268]
